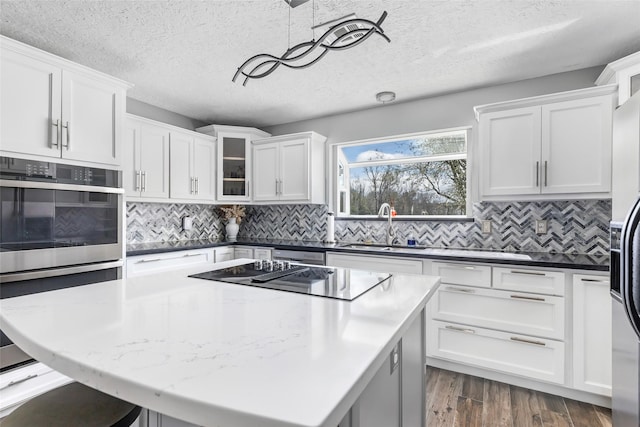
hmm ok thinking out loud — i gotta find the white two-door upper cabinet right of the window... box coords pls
[475,86,615,200]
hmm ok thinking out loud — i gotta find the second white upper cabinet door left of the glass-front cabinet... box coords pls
[169,132,196,199]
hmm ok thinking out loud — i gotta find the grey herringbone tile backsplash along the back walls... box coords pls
[127,200,611,255]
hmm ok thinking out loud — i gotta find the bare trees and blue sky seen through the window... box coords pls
[338,130,467,216]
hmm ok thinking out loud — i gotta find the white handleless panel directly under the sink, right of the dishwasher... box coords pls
[327,252,422,274]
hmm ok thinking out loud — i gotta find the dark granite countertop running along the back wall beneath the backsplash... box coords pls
[127,239,609,271]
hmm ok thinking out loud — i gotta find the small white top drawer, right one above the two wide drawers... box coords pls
[493,267,564,295]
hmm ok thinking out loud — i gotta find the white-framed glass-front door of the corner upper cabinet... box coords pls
[217,132,251,201]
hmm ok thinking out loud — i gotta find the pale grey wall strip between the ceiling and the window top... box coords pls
[263,66,604,143]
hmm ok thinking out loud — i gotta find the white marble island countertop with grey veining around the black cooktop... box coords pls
[0,260,438,427]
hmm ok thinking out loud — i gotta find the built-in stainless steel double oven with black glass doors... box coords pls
[0,157,124,371]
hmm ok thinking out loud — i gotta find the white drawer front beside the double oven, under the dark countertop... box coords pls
[127,249,213,277]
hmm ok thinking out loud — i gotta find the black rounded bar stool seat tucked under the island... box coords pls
[0,382,141,427]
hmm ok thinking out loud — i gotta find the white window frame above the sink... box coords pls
[327,126,473,222]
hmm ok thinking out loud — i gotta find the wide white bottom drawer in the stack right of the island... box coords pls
[427,320,565,384]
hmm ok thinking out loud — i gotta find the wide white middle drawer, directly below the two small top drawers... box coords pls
[431,284,564,340]
